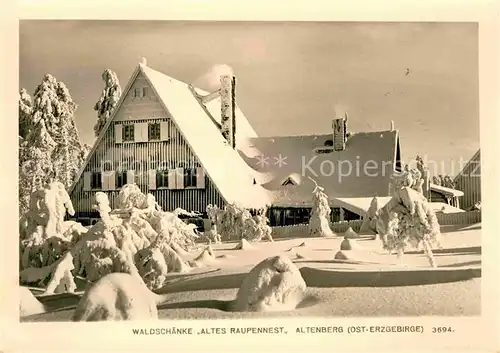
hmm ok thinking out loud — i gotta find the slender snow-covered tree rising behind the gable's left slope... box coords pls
[94,69,122,137]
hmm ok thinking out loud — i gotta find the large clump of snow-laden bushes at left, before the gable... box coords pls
[20,182,198,290]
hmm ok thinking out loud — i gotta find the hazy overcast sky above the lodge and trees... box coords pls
[19,21,479,174]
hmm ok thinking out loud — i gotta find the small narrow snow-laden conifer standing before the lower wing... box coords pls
[309,178,334,237]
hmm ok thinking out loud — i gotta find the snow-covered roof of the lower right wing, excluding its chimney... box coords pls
[240,130,398,207]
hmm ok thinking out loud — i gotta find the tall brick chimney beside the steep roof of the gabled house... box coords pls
[220,75,236,148]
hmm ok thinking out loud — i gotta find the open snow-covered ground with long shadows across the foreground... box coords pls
[21,225,481,322]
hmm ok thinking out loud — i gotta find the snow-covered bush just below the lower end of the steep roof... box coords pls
[207,204,272,242]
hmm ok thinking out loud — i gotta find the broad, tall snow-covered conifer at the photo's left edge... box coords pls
[19,74,83,212]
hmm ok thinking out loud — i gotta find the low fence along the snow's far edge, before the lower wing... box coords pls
[272,211,481,238]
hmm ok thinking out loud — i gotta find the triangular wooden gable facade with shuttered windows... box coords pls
[70,73,224,218]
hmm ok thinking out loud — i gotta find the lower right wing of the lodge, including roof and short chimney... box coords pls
[240,128,401,225]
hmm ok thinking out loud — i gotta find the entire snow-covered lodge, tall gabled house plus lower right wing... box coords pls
[69,64,401,225]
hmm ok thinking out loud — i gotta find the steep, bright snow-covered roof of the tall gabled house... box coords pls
[70,65,271,208]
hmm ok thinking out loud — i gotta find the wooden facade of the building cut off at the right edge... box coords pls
[454,150,481,210]
